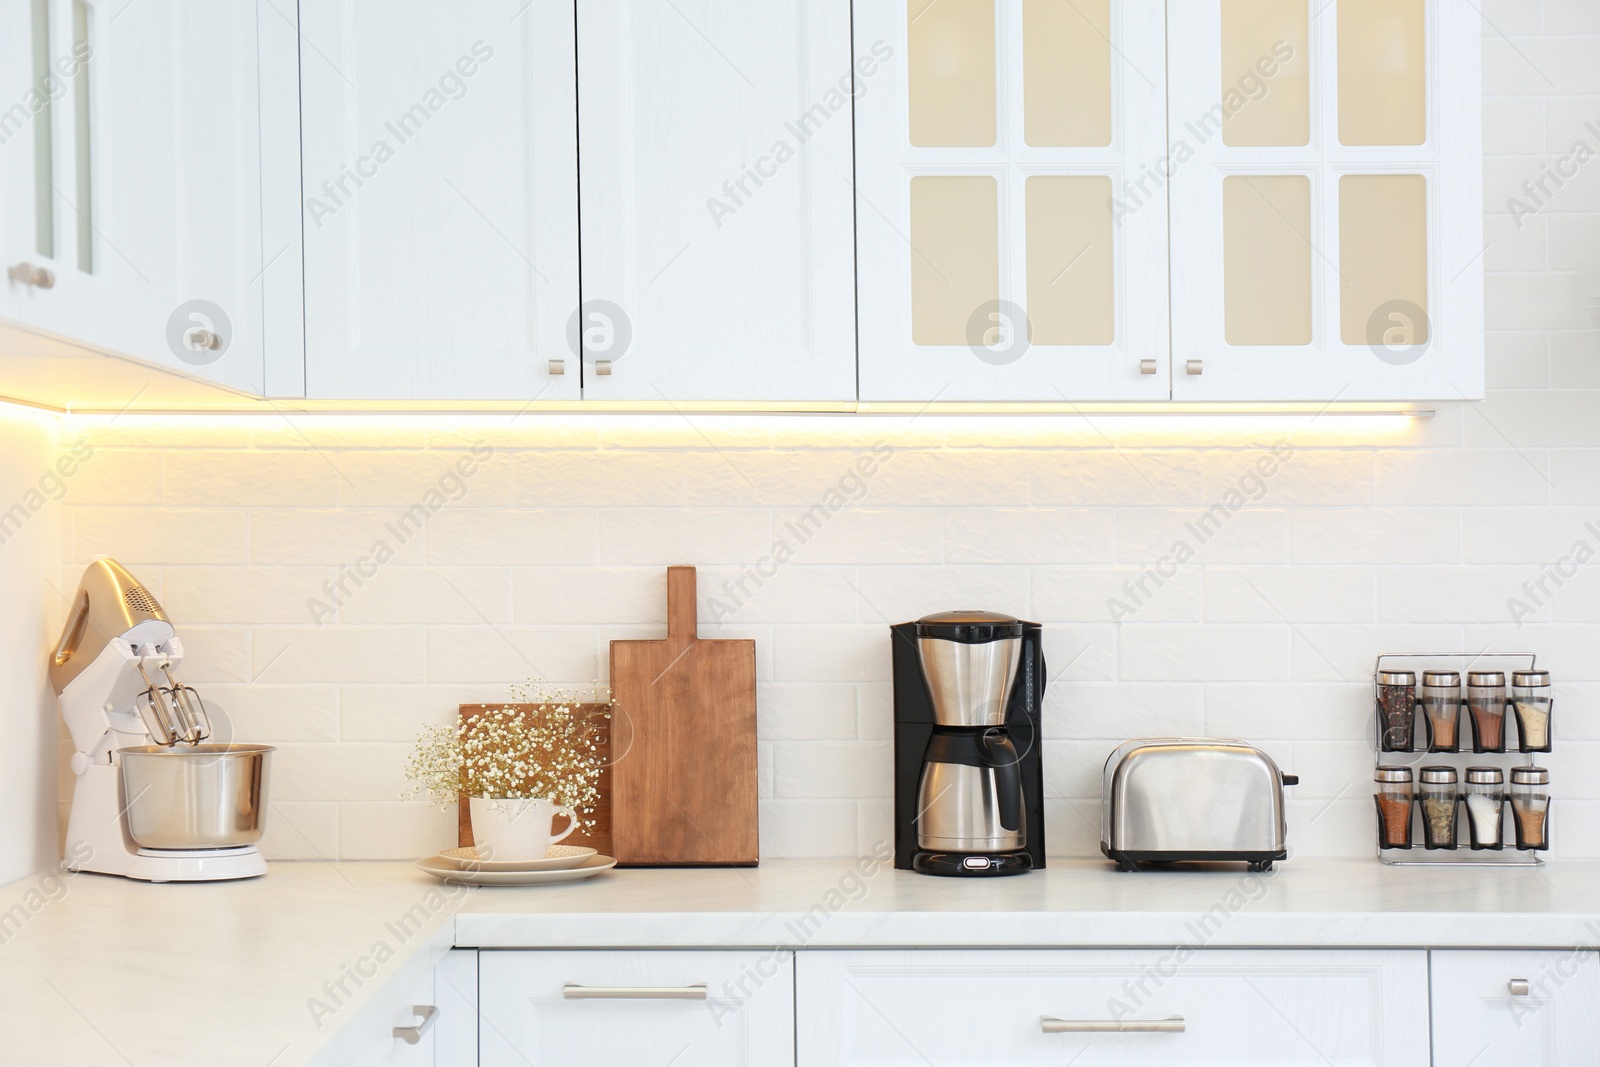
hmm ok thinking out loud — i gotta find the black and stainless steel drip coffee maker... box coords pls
[890,611,1045,877]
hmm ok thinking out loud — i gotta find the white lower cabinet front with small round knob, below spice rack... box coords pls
[1432,949,1600,1067]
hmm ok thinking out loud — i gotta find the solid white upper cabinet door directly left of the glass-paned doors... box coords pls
[578,0,856,403]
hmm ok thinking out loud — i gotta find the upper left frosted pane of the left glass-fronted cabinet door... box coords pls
[906,0,995,147]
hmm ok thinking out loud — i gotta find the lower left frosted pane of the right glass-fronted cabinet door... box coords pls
[1222,174,1312,346]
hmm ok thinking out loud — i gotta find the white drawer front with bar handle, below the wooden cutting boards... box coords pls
[478,950,795,1067]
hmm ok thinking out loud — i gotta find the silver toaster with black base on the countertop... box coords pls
[1101,737,1299,870]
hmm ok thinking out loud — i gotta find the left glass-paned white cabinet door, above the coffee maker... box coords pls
[854,0,1170,403]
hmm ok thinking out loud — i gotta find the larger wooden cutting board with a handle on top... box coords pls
[611,566,757,867]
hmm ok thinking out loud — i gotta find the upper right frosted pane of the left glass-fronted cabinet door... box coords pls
[1022,0,1110,147]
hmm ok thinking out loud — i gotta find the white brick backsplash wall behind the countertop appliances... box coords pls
[34,0,1600,859]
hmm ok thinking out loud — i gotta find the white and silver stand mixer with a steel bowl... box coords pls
[50,557,272,881]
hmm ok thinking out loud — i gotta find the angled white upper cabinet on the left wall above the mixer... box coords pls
[0,0,291,402]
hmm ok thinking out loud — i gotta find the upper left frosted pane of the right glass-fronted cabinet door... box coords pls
[1221,0,1310,147]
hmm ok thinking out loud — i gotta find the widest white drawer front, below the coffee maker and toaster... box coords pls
[797,949,1429,1067]
